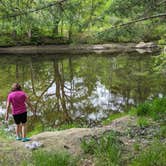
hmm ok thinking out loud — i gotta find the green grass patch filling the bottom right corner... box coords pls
[130,142,166,166]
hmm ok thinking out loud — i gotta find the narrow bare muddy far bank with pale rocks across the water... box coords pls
[0,43,158,54]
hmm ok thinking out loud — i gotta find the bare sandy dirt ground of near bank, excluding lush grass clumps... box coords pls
[0,115,166,166]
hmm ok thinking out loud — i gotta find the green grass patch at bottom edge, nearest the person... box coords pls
[22,150,77,166]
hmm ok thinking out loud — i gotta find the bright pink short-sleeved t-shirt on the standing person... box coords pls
[7,91,27,115]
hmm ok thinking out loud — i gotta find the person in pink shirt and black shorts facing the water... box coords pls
[5,83,35,142]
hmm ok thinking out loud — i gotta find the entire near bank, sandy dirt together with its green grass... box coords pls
[0,93,166,166]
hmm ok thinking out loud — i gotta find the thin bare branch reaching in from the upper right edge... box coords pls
[112,13,166,28]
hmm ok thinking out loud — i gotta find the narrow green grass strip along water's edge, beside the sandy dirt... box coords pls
[102,112,128,125]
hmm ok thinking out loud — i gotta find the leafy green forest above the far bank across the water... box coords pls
[0,0,166,46]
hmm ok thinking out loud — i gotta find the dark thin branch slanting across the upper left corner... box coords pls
[0,0,66,19]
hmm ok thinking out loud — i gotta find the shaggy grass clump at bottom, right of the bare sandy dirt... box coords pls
[81,132,122,166]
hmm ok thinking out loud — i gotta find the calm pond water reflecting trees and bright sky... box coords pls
[0,52,166,130]
